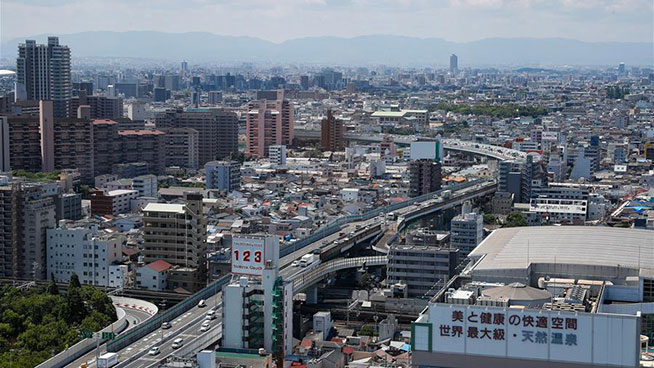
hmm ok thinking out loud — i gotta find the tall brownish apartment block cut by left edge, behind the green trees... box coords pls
[0,182,57,280]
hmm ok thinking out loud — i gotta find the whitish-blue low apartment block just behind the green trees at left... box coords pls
[47,225,125,287]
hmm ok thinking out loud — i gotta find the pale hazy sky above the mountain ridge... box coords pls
[0,0,654,42]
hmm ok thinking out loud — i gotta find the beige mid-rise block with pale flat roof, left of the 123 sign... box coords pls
[143,193,207,291]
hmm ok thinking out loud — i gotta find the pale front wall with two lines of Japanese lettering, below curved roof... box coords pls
[412,303,640,368]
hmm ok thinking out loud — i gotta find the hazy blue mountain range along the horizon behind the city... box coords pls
[0,31,654,67]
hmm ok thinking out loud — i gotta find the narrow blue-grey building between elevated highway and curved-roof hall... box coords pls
[450,202,484,257]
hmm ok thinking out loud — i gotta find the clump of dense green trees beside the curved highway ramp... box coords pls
[0,274,117,368]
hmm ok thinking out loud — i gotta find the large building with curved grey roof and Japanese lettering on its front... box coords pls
[412,226,654,368]
